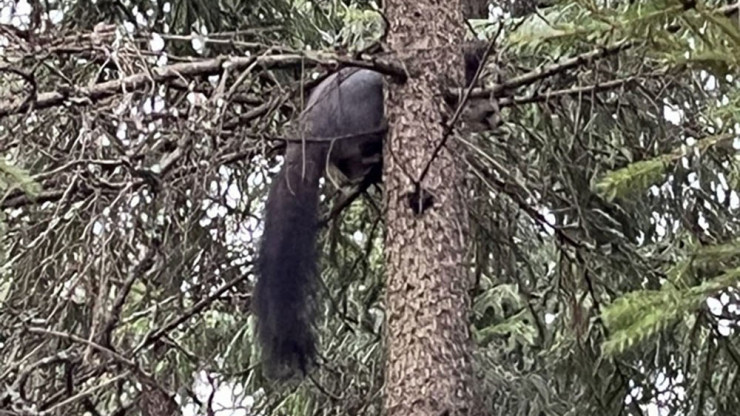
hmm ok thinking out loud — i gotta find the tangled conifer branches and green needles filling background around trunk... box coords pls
[0,0,740,416]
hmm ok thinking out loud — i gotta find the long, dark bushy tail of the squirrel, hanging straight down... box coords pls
[254,143,325,378]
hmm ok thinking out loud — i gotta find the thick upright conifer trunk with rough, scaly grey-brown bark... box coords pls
[384,0,478,416]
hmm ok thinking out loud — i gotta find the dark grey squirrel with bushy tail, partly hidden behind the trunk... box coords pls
[254,49,482,378]
